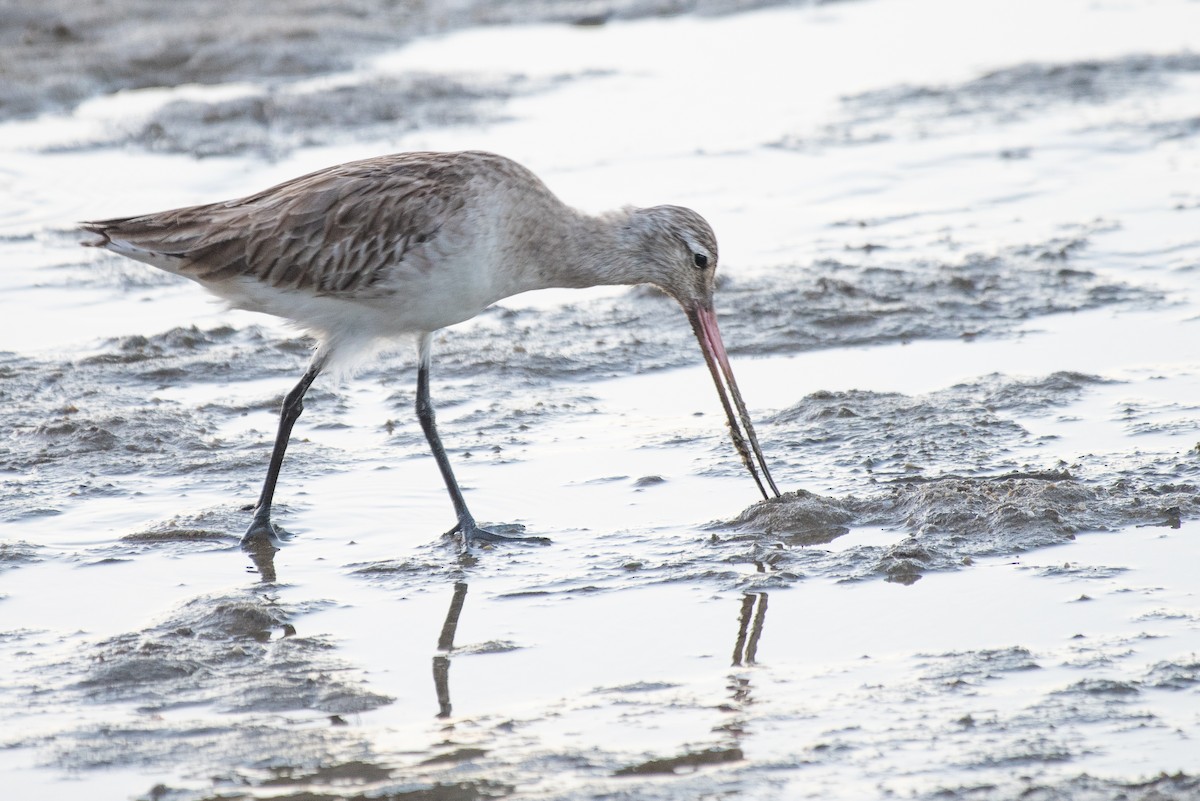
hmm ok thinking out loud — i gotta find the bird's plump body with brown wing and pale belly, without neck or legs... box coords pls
[82,151,578,345]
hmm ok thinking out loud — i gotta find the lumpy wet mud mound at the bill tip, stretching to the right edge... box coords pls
[714,472,1200,584]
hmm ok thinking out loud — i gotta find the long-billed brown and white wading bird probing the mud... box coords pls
[82,151,779,547]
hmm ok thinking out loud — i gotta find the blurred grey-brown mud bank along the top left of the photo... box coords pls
[0,0,806,123]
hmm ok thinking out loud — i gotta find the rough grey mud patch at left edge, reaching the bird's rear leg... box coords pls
[0,326,328,519]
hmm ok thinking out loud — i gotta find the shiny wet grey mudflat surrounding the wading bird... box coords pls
[0,0,1200,801]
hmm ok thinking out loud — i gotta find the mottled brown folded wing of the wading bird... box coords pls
[84,153,468,295]
